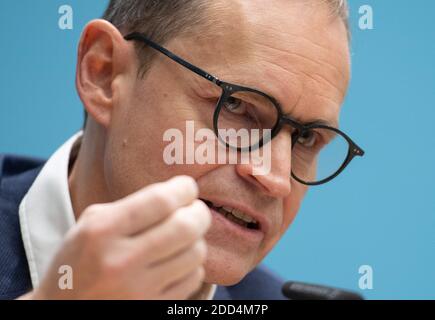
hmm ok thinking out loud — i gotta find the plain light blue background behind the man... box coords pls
[0,0,435,299]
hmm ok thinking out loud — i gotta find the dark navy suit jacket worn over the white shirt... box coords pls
[0,155,284,300]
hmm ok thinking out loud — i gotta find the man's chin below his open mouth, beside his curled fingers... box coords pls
[204,242,256,286]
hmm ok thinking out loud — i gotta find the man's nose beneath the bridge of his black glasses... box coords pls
[236,130,291,198]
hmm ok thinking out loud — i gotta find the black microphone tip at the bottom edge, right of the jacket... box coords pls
[282,281,364,300]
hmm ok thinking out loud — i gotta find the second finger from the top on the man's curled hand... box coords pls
[132,200,211,266]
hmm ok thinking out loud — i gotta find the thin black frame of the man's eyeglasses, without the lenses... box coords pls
[124,32,365,186]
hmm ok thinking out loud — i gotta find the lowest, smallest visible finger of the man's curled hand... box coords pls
[161,267,205,300]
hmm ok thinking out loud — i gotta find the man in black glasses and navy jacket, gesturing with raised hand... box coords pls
[0,0,363,299]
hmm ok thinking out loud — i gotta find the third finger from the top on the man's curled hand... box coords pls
[146,240,207,288]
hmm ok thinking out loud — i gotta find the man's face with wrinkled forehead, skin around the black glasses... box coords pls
[105,0,350,285]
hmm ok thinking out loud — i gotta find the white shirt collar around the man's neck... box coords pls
[19,132,216,300]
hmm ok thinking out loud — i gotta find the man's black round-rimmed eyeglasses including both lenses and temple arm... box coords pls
[124,32,364,186]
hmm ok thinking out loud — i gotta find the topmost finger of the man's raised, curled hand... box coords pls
[112,176,198,235]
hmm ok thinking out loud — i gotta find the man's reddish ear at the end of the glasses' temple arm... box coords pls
[76,20,131,127]
